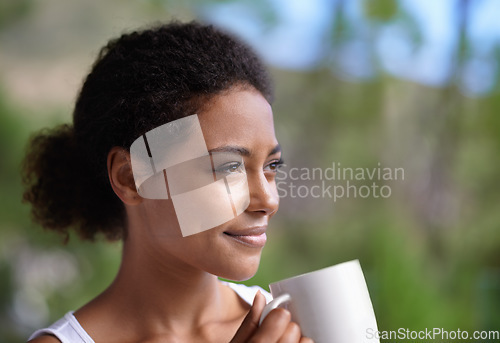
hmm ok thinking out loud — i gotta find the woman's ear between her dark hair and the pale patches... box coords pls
[108,147,142,205]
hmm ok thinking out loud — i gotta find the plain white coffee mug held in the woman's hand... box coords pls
[260,260,379,343]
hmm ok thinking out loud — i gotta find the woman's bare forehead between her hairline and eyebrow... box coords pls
[199,89,277,150]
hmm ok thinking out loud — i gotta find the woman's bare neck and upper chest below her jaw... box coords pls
[75,236,247,342]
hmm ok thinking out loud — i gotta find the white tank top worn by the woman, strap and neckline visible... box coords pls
[29,281,272,343]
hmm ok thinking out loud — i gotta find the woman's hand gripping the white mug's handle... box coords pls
[230,292,314,343]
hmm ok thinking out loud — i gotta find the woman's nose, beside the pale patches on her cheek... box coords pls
[247,172,279,216]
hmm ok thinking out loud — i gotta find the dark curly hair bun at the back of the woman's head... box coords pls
[22,124,121,239]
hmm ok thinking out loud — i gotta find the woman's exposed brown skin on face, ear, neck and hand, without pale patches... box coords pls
[28,87,312,343]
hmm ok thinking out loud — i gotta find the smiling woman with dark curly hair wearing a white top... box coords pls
[24,23,311,343]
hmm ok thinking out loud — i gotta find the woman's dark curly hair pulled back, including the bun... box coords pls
[23,22,272,240]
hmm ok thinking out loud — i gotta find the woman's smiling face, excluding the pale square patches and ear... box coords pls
[128,88,281,280]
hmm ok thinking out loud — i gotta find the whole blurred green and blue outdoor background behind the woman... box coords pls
[0,0,500,342]
